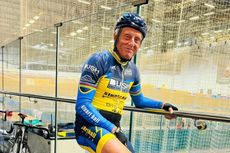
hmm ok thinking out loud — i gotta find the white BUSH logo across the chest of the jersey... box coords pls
[108,79,129,92]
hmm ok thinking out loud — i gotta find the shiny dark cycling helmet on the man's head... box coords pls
[115,13,147,39]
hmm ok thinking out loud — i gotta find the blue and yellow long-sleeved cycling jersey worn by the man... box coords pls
[76,51,163,131]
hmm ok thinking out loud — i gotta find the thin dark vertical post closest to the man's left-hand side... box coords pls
[54,22,62,153]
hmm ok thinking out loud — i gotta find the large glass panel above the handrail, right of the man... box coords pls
[138,0,230,114]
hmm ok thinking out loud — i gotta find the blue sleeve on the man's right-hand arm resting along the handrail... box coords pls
[130,68,163,109]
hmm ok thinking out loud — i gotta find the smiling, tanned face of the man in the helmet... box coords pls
[114,27,142,60]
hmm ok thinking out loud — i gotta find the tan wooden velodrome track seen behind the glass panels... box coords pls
[0,71,230,115]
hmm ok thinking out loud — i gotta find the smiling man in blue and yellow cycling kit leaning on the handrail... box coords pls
[75,13,177,153]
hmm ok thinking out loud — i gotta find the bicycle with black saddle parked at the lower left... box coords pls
[8,113,49,153]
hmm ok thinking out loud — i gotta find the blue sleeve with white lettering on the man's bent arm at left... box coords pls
[75,54,115,131]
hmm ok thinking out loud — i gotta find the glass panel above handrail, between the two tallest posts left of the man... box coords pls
[22,27,56,96]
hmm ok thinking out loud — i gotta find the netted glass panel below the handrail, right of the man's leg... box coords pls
[128,112,230,153]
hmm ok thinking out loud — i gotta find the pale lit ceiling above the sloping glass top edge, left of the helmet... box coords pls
[0,0,133,45]
